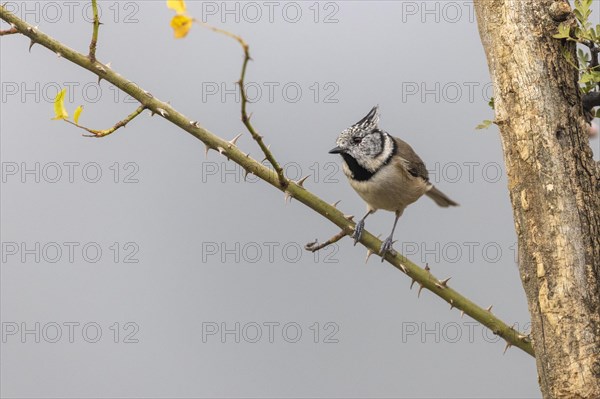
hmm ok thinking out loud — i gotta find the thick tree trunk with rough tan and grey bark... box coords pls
[475,0,600,398]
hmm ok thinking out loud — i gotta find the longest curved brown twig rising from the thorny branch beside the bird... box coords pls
[194,20,289,188]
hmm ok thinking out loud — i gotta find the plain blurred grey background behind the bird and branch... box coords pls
[0,1,600,398]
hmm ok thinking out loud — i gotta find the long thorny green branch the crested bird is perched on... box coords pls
[0,6,533,356]
